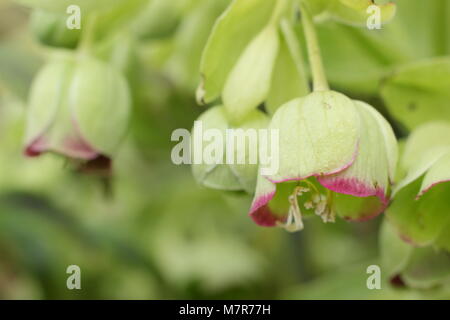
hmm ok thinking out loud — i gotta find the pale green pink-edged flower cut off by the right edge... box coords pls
[386,121,450,251]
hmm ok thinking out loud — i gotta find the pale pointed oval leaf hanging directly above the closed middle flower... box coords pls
[222,25,279,123]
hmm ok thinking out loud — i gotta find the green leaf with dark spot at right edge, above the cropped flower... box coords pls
[381,58,450,128]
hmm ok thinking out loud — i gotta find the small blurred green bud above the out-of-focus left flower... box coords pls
[31,10,81,49]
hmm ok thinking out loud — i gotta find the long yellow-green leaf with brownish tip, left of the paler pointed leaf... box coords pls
[197,0,275,103]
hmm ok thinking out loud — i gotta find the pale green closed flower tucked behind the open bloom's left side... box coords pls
[191,106,269,193]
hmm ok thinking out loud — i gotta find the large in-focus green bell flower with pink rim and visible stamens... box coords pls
[250,91,397,231]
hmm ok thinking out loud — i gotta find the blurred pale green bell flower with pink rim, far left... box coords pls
[25,55,131,161]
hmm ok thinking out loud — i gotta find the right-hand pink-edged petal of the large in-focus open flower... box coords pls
[317,101,397,221]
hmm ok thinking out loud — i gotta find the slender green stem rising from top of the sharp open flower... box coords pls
[300,1,330,91]
